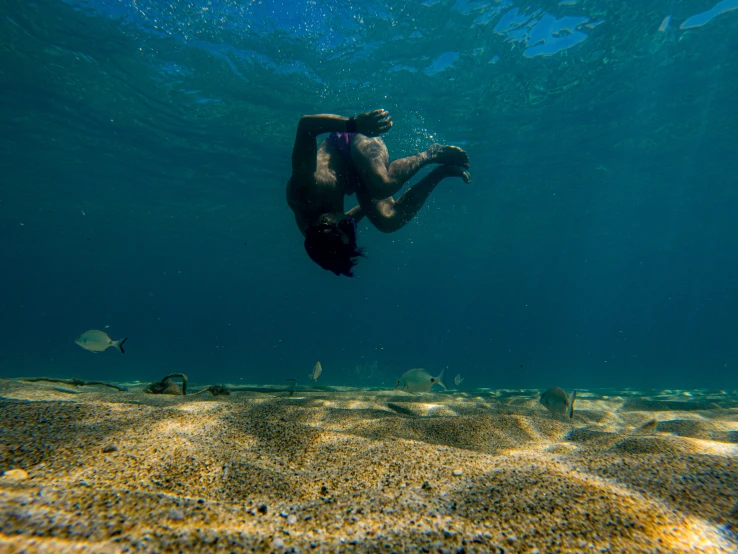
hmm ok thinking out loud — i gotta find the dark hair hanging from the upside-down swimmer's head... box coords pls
[305,218,364,277]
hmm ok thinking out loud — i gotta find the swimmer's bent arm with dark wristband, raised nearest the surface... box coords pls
[292,110,392,181]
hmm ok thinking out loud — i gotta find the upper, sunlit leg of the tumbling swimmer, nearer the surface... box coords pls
[351,135,469,200]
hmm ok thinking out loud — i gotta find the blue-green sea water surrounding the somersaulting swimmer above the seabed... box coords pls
[0,0,738,389]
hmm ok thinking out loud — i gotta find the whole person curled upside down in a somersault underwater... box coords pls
[287,110,471,276]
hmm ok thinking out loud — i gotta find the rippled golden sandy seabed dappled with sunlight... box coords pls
[0,379,738,553]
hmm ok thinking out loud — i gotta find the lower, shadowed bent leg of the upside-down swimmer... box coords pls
[357,165,471,233]
